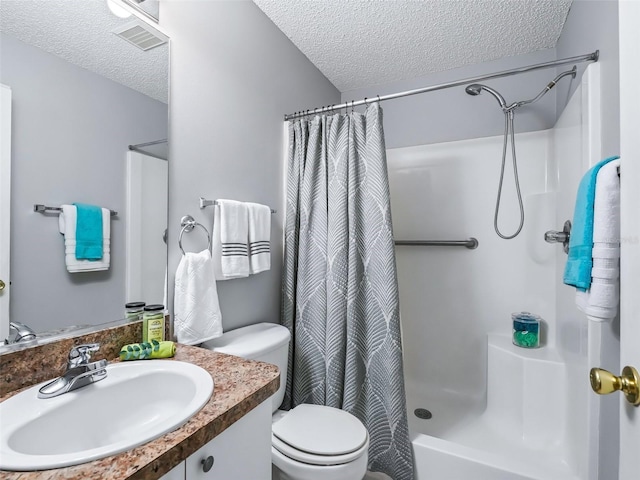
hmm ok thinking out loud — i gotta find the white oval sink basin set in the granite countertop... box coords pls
[0,360,213,471]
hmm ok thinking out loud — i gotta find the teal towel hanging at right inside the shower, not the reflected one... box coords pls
[563,156,620,292]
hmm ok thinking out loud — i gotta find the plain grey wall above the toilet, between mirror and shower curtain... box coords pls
[160,0,340,330]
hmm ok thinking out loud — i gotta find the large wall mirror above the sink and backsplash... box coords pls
[0,0,169,343]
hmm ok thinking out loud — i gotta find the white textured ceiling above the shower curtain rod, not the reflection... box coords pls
[253,0,571,92]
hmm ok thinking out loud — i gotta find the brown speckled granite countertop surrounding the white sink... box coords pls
[0,344,280,480]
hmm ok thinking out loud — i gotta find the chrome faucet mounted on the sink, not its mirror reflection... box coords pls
[38,343,107,398]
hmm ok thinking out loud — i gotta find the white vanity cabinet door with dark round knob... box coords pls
[186,399,271,480]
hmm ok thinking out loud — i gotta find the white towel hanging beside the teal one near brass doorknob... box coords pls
[576,160,620,322]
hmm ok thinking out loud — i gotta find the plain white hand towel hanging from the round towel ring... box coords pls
[173,250,222,345]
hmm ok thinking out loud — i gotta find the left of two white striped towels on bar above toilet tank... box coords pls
[212,200,249,280]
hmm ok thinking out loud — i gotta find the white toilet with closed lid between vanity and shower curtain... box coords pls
[201,323,369,480]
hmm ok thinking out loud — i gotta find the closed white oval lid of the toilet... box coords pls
[272,404,368,457]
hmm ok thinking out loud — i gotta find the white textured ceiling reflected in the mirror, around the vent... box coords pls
[0,0,169,103]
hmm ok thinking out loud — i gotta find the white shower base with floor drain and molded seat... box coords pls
[406,335,580,480]
